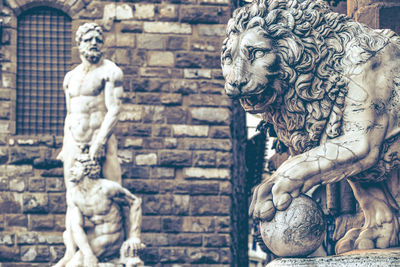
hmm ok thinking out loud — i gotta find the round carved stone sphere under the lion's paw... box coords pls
[260,195,326,257]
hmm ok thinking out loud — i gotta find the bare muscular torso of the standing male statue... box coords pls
[64,59,121,144]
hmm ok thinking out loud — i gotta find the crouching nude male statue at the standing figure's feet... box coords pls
[57,153,142,267]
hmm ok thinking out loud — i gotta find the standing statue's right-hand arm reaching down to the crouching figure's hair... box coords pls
[89,66,123,159]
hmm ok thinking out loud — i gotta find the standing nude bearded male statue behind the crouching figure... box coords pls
[55,23,138,267]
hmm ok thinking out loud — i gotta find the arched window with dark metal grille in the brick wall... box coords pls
[16,7,71,135]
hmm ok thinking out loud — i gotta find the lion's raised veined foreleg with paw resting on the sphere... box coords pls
[250,93,388,220]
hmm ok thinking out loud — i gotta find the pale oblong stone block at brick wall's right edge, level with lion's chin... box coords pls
[190,107,231,124]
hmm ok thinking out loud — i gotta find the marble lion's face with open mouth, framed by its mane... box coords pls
[222,27,279,113]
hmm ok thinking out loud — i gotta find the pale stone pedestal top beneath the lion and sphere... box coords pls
[266,248,400,267]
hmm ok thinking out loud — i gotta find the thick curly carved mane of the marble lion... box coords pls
[222,0,390,154]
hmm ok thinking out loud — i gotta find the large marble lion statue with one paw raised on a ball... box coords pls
[221,0,400,254]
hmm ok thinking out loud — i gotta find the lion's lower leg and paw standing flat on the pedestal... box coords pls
[335,181,399,254]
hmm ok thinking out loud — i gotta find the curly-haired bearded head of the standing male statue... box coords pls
[75,23,104,64]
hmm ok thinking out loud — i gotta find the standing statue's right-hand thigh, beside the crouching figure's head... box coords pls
[102,135,122,184]
